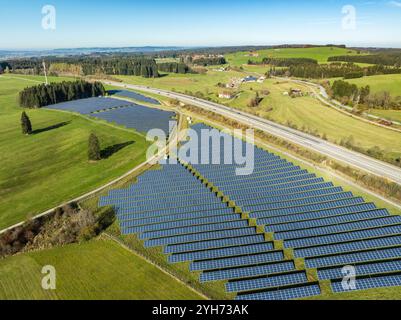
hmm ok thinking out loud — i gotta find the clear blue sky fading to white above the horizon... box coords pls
[0,0,401,49]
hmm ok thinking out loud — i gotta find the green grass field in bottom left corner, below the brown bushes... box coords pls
[0,240,201,300]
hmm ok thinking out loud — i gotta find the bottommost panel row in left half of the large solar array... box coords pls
[236,284,321,300]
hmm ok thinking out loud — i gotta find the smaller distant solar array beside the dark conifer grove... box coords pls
[47,96,175,134]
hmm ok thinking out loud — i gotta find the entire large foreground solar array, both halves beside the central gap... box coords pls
[99,124,401,300]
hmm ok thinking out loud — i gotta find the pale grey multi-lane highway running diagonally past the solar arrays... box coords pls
[103,81,401,185]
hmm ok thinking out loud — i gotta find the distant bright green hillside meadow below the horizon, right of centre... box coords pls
[225,47,356,66]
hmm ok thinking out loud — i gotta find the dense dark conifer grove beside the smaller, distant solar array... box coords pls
[19,80,106,108]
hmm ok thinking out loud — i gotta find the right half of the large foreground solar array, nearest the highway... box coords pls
[184,124,401,298]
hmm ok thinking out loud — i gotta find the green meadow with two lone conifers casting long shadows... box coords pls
[0,76,148,229]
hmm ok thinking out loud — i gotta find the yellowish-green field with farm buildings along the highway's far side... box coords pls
[115,71,401,164]
